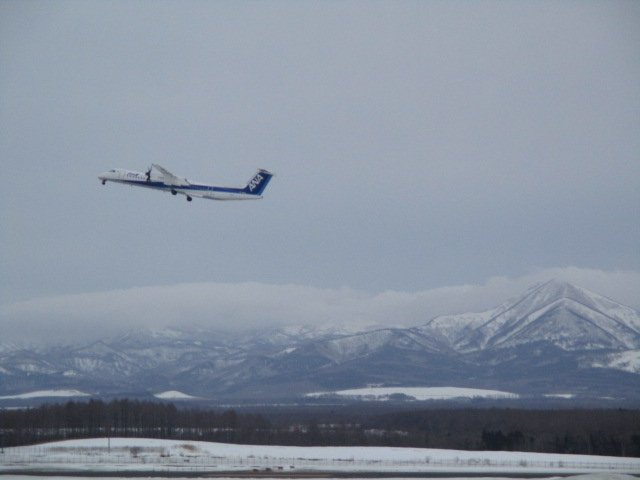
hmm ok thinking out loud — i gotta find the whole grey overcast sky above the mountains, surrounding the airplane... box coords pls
[0,0,640,339]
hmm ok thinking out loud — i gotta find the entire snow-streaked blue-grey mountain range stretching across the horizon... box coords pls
[0,281,640,401]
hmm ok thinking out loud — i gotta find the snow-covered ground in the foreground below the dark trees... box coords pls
[0,438,640,477]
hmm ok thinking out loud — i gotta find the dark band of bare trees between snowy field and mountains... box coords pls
[0,399,640,457]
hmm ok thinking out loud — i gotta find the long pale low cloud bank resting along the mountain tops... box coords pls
[0,267,640,342]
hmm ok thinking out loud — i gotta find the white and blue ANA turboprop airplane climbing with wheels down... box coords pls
[98,163,273,202]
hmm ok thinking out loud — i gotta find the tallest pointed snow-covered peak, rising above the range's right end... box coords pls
[421,280,640,352]
